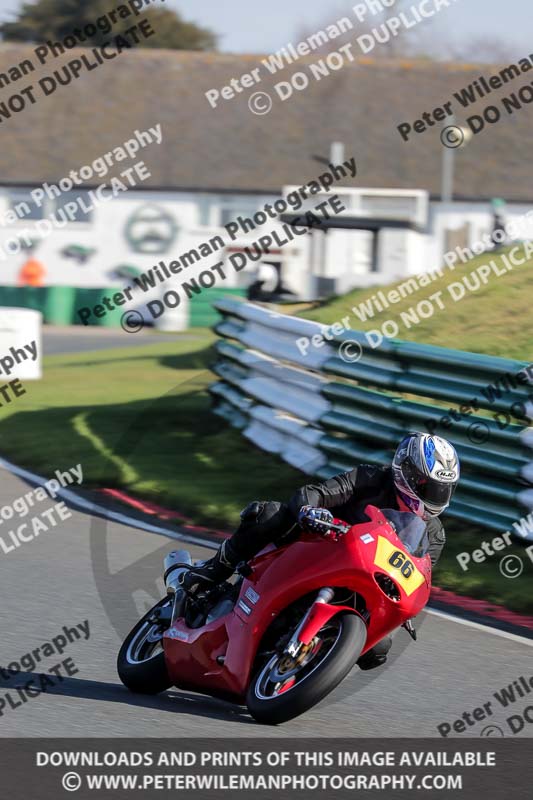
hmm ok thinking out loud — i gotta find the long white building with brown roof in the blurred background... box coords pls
[0,45,533,324]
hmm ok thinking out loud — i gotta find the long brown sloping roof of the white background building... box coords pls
[0,44,533,201]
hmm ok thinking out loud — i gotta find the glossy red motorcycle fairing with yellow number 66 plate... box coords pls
[164,506,431,701]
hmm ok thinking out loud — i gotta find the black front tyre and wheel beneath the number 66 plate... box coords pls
[246,611,367,725]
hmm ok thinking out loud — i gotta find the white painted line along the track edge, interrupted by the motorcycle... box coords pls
[0,458,533,647]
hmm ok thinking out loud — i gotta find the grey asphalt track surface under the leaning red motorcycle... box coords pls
[0,468,533,738]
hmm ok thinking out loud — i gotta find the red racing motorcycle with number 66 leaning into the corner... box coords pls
[118,506,431,724]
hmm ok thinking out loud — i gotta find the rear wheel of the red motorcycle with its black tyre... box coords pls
[117,597,172,694]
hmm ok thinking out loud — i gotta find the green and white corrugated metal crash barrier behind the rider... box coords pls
[210,299,533,540]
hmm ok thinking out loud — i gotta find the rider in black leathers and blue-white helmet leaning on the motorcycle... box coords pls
[183,433,459,669]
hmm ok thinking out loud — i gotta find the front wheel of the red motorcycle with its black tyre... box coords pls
[246,611,366,725]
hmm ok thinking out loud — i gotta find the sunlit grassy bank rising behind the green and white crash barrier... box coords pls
[302,242,533,360]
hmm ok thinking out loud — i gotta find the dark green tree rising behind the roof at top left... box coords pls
[0,0,217,50]
